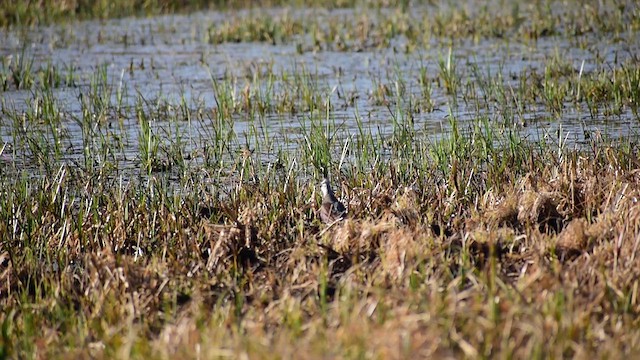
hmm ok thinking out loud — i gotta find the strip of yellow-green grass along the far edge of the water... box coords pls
[0,0,640,41]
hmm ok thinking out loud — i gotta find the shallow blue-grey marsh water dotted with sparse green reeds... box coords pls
[0,9,640,176]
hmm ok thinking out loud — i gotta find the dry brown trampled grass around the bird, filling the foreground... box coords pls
[0,141,640,358]
